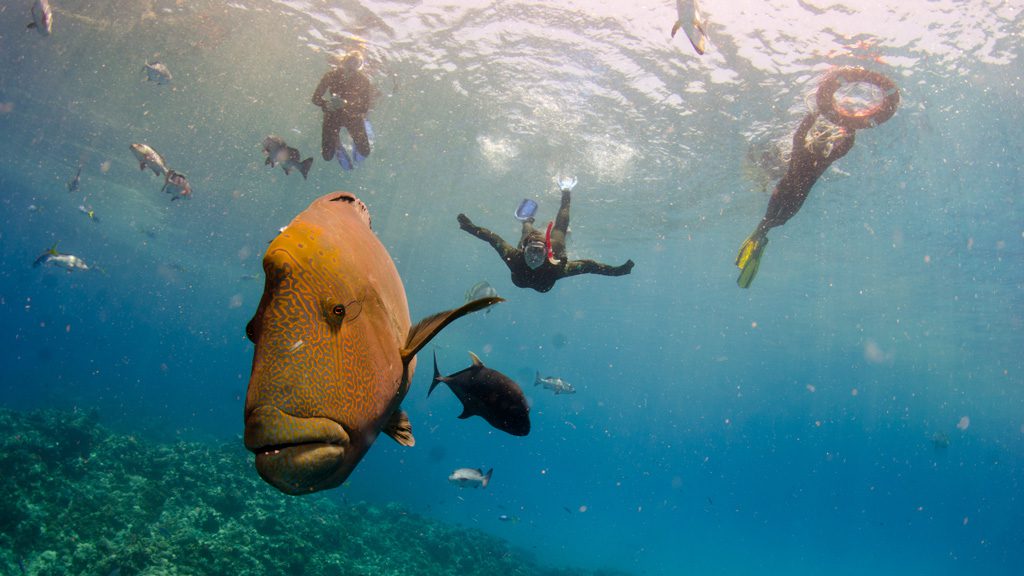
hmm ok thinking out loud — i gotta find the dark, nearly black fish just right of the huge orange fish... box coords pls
[427,352,529,436]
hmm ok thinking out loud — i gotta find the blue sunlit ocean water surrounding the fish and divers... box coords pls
[0,0,1024,575]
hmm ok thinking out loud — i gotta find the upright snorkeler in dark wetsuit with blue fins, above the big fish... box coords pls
[312,52,377,160]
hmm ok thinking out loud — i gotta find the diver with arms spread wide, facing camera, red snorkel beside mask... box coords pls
[459,184,633,292]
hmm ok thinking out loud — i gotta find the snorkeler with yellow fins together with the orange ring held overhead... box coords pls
[736,68,899,288]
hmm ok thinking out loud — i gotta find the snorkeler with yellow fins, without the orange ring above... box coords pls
[736,113,854,288]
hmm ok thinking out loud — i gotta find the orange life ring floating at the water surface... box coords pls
[816,67,899,130]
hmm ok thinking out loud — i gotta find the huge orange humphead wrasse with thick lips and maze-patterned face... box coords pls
[245,192,502,494]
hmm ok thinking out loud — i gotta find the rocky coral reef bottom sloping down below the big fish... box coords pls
[0,410,622,576]
